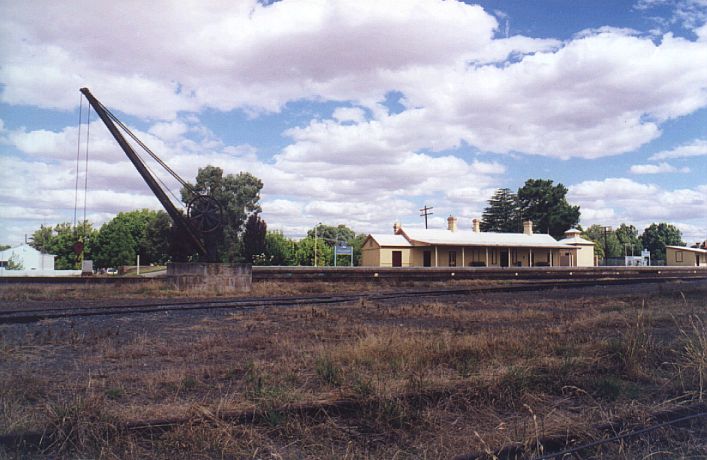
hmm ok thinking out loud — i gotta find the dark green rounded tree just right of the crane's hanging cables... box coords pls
[93,218,137,268]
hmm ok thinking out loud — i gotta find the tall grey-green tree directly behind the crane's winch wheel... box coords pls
[181,165,263,262]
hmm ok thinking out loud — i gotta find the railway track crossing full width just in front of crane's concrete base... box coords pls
[0,273,707,324]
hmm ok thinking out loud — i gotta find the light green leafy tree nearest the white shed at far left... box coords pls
[29,222,98,270]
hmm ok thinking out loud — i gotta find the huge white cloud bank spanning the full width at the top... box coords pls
[0,0,707,158]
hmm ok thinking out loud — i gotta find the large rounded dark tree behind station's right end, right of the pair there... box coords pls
[517,179,580,238]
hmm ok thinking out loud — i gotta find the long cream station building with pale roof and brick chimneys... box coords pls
[361,216,594,267]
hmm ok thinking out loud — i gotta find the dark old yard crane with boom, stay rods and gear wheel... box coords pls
[80,88,223,262]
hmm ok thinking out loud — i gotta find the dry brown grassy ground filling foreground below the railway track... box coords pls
[0,282,707,458]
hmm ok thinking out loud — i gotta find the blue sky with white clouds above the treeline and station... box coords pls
[0,0,707,245]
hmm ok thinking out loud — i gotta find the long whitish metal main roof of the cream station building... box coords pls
[403,229,574,249]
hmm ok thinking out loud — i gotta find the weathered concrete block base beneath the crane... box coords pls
[167,262,253,294]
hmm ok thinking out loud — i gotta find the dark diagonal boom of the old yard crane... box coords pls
[81,88,210,262]
